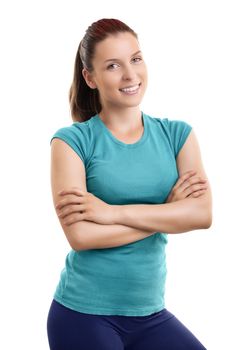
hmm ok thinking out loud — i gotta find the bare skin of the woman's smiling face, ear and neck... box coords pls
[83,32,147,141]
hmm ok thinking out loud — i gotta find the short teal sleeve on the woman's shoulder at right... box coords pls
[166,118,192,157]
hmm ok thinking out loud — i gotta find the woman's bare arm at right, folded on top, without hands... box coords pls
[114,130,212,233]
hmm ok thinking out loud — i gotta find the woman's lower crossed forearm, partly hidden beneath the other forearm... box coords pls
[73,221,155,250]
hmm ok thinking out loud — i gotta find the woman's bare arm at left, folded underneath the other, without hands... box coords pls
[51,138,154,250]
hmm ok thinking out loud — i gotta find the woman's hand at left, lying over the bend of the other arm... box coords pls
[55,187,113,226]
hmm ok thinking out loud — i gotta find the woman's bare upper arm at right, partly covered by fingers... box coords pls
[176,129,212,227]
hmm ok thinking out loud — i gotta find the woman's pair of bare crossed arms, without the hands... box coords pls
[51,130,212,250]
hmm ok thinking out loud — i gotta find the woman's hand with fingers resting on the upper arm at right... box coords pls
[166,170,207,203]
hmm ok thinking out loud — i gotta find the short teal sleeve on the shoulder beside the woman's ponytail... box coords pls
[50,123,88,164]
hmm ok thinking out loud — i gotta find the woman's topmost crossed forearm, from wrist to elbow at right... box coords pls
[114,198,209,233]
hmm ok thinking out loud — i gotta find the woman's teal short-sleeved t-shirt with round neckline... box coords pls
[50,112,192,316]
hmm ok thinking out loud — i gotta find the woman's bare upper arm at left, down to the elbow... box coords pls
[51,138,87,249]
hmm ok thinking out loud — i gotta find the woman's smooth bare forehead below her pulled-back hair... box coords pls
[94,32,140,62]
